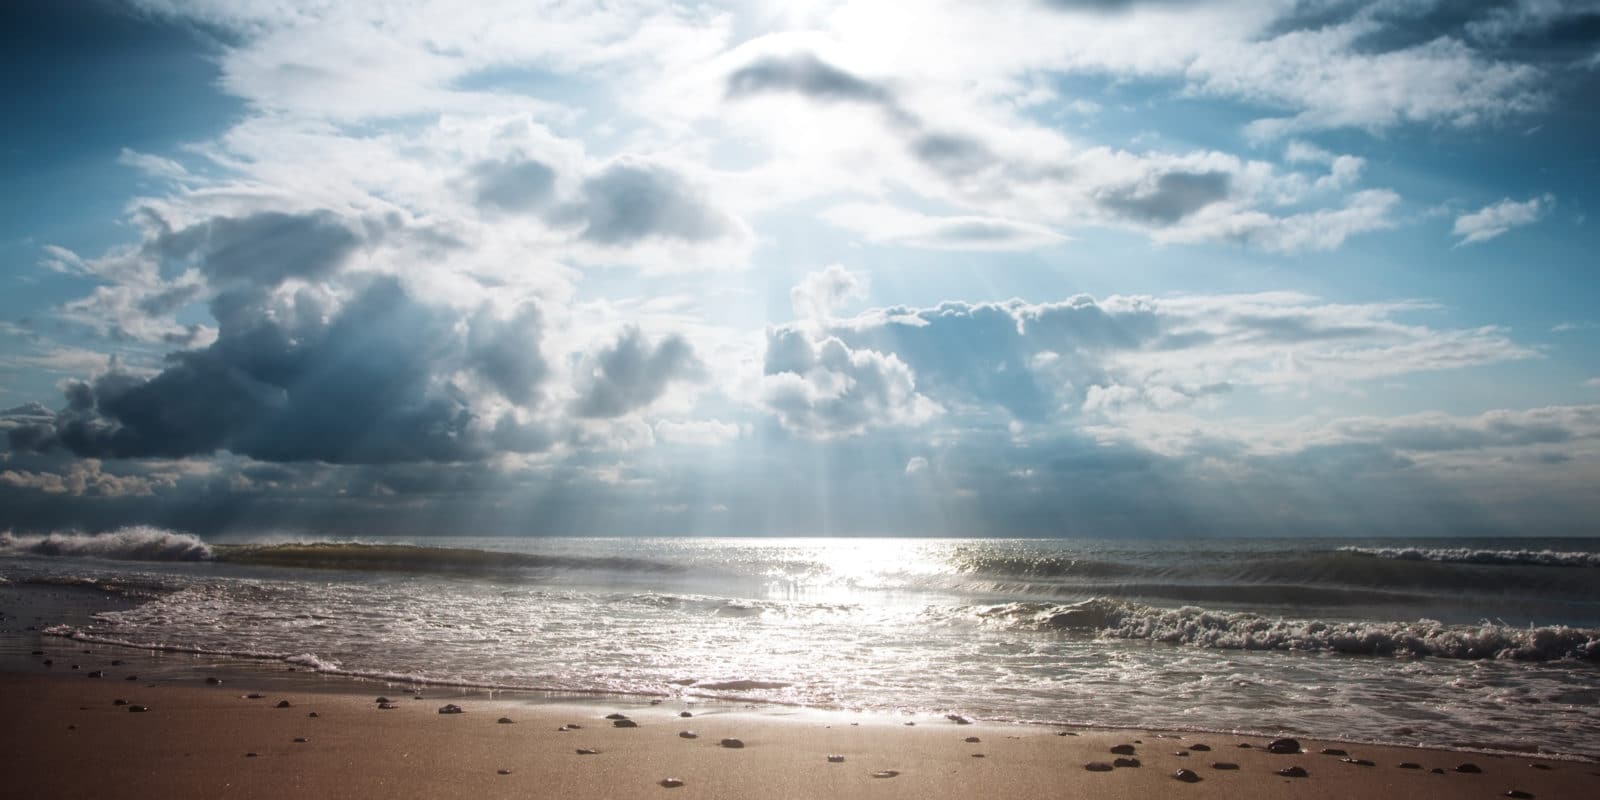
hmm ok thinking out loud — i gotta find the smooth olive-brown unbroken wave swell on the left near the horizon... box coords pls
[213,542,683,573]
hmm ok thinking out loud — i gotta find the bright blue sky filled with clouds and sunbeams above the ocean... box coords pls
[0,0,1600,538]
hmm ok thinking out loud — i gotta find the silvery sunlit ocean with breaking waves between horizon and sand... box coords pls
[0,528,1600,757]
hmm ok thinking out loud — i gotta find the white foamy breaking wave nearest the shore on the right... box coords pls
[976,598,1600,661]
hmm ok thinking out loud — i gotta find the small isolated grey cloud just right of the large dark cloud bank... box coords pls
[573,326,706,418]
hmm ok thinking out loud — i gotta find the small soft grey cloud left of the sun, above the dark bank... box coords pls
[555,163,736,246]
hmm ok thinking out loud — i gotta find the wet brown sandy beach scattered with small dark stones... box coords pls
[0,661,1600,798]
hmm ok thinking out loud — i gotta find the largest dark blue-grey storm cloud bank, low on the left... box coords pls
[10,278,546,464]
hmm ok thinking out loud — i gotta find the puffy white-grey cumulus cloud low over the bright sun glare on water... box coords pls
[760,328,941,438]
